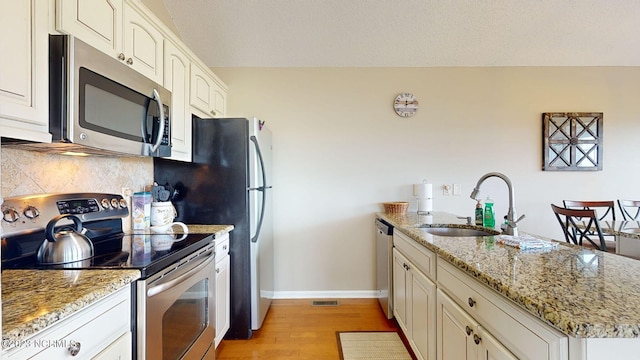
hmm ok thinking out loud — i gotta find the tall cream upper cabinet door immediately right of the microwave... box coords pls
[164,41,191,161]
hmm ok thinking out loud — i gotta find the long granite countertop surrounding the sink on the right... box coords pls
[377,212,640,338]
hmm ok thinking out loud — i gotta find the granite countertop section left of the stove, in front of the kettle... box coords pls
[2,269,140,344]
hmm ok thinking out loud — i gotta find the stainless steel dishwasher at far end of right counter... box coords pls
[376,219,393,319]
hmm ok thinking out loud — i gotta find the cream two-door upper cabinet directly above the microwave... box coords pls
[56,0,164,85]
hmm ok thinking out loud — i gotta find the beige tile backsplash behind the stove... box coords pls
[0,148,153,197]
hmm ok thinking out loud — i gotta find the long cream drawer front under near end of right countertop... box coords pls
[438,259,568,359]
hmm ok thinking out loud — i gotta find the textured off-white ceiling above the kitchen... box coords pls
[162,0,640,67]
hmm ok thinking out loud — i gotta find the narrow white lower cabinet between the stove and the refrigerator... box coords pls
[215,234,231,347]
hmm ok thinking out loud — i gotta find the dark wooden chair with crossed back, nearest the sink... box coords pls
[551,204,607,251]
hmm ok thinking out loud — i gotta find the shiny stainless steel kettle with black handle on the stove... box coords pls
[37,214,93,265]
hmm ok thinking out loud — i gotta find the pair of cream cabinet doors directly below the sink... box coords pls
[393,236,436,359]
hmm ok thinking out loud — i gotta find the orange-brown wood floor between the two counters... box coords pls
[216,299,398,360]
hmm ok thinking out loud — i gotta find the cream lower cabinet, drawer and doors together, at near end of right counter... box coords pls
[437,259,569,360]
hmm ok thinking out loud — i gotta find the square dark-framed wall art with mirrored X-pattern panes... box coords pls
[542,113,603,171]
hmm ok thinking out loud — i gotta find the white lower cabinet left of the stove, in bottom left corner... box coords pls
[2,286,133,360]
